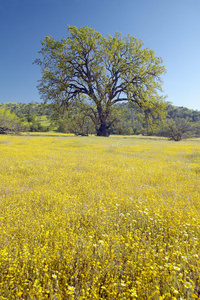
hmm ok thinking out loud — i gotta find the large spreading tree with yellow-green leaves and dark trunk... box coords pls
[35,26,166,136]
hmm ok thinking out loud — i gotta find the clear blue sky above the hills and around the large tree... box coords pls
[0,0,200,110]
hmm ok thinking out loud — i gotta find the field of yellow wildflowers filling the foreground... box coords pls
[0,134,200,300]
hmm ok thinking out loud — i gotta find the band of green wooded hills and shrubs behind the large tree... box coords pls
[0,102,200,141]
